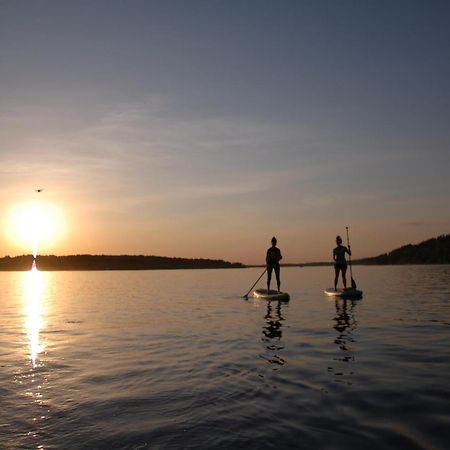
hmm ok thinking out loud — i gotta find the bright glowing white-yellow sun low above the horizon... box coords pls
[6,201,65,257]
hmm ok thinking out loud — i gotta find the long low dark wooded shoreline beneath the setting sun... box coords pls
[0,255,245,271]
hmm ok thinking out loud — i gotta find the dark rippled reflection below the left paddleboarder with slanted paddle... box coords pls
[261,301,286,370]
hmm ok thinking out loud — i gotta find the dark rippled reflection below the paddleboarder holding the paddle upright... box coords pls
[328,299,358,384]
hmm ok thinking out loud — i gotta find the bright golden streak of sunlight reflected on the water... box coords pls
[25,264,45,367]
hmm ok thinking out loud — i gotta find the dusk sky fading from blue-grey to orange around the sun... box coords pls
[0,0,450,264]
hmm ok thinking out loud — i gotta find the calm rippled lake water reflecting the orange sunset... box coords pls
[0,266,450,450]
